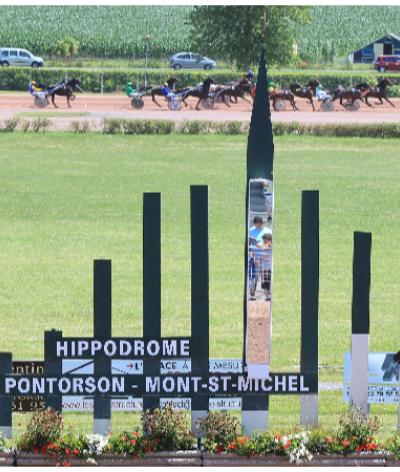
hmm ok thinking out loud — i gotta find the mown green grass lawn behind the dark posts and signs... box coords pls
[0,133,400,432]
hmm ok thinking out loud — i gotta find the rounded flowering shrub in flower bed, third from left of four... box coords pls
[197,411,240,452]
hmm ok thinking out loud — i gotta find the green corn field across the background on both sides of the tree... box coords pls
[0,5,400,63]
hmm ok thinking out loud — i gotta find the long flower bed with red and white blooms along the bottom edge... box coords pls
[0,408,400,467]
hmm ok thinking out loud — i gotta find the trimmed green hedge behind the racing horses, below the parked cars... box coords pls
[0,67,400,96]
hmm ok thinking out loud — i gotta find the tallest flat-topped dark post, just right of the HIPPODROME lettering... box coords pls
[190,185,209,432]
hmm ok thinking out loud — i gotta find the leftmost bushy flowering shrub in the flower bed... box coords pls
[17,408,63,453]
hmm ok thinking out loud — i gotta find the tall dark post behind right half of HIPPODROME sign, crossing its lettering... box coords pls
[143,193,161,410]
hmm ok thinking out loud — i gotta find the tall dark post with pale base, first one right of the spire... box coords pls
[300,190,319,427]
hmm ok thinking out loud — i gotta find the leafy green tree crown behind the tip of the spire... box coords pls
[189,5,309,69]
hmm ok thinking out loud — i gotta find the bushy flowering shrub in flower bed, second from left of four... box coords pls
[142,407,194,451]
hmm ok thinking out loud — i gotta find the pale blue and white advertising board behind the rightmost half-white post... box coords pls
[343,352,400,403]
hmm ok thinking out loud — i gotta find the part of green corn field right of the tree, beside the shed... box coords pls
[297,6,400,62]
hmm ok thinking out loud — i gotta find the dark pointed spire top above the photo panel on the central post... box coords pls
[247,49,274,180]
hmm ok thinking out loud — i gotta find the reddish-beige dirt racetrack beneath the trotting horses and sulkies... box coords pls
[0,93,400,129]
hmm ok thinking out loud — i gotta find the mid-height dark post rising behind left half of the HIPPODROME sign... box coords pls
[93,260,112,434]
